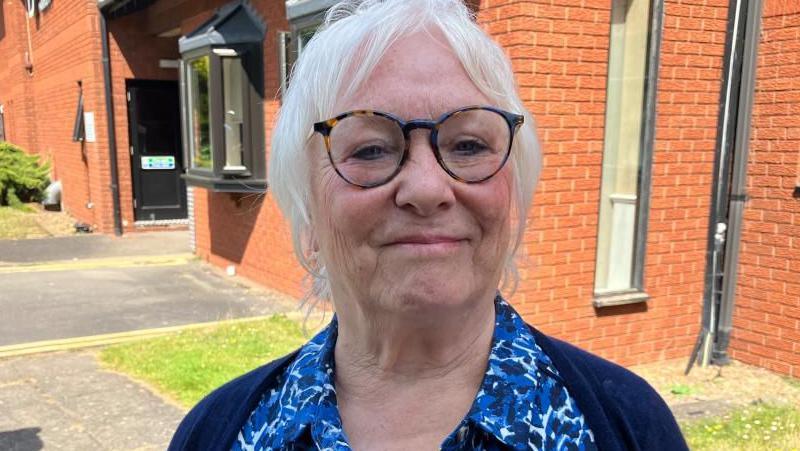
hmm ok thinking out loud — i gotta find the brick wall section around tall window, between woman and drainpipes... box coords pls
[468,0,727,364]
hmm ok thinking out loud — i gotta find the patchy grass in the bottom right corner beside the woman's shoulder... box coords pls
[681,404,800,451]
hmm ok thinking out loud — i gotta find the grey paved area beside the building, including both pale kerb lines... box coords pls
[0,231,296,350]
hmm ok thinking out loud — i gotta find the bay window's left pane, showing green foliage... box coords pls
[187,56,213,169]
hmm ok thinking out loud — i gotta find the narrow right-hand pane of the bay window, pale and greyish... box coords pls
[222,57,244,169]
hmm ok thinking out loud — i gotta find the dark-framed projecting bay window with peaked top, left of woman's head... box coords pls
[178,0,266,192]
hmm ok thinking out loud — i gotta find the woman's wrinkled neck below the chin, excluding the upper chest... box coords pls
[335,297,495,396]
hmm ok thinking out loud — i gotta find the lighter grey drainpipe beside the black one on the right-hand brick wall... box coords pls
[712,0,761,364]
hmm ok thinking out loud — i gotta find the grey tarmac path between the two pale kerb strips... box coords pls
[0,259,293,348]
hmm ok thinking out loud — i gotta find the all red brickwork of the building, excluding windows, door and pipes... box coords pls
[7,0,800,375]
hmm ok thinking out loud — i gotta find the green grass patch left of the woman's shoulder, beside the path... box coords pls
[100,316,306,407]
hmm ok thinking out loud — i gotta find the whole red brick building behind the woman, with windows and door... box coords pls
[0,0,800,377]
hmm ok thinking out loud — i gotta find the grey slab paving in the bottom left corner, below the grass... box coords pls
[0,351,184,451]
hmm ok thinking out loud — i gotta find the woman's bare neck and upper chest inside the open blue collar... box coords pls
[334,296,495,450]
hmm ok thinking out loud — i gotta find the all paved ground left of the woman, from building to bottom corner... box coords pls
[0,232,304,451]
